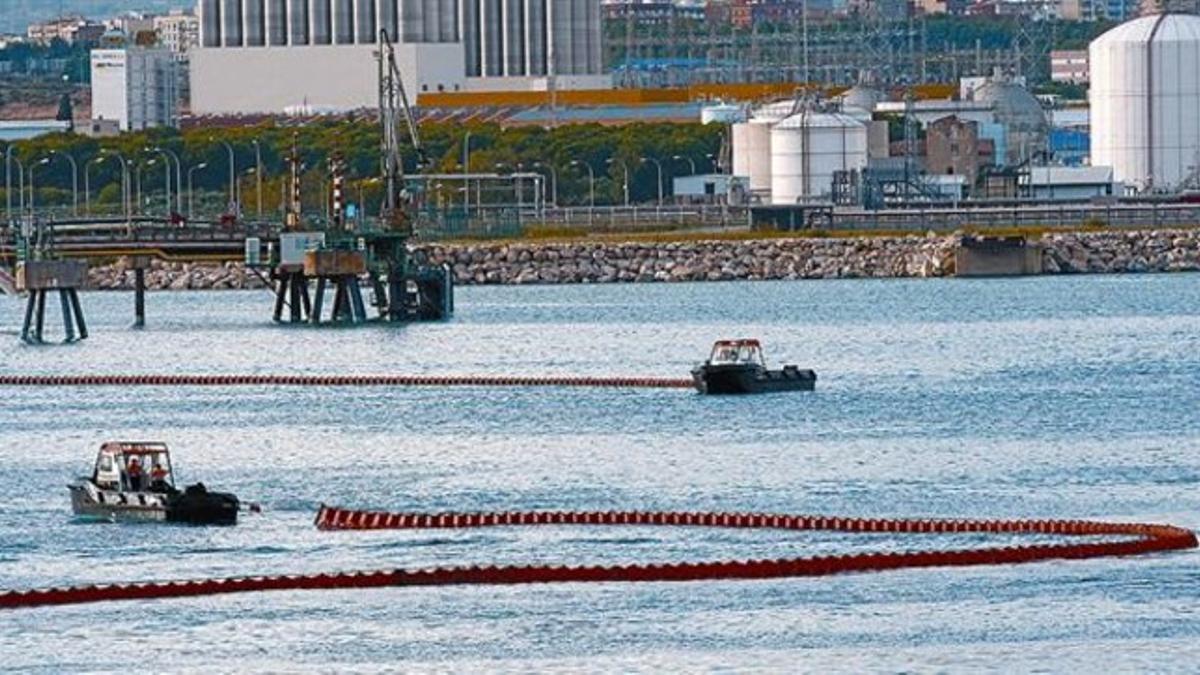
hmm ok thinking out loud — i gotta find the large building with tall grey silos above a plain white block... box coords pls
[191,0,612,114]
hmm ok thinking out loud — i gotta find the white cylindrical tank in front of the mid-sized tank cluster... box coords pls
[770,110,866,204]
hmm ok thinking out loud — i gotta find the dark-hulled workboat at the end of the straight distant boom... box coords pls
[691,340,817,394]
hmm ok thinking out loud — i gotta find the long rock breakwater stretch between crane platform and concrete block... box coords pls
[427,237,955,285]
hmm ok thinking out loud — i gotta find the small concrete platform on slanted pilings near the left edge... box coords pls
[16,261,88,345]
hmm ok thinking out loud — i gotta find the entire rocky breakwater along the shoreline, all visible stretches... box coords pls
[79,229,1200,291]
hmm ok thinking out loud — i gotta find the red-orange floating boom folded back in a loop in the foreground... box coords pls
[0,506,1196,609]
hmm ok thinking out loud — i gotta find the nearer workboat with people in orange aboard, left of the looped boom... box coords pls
[67,442,241,525]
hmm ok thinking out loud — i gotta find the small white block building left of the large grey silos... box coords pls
[91,47,179,131]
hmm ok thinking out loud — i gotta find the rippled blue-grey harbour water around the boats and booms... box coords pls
[0,275,1200,671]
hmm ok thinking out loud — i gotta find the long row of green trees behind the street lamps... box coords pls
[0,119,724,218]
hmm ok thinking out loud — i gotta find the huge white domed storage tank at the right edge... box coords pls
[1088,14,1200,190]
